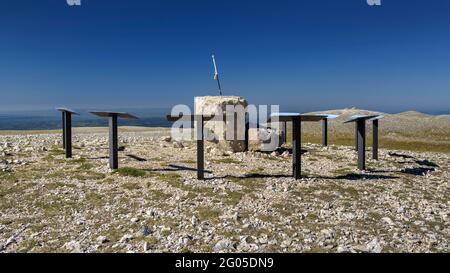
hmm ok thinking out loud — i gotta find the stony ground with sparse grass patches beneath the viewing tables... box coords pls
[0,126,450,252]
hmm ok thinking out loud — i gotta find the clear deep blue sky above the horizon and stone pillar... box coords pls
[0,0,450,112]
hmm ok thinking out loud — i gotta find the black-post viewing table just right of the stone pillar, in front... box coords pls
[270,113,302,179]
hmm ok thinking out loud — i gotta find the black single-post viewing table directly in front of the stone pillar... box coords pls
[167,115,219,180]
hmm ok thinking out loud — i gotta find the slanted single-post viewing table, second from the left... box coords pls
[90,111,137,170]
